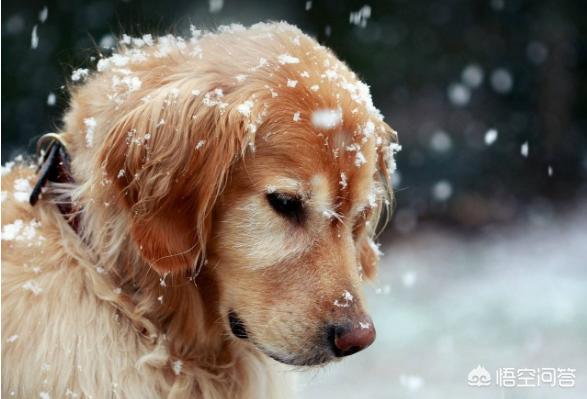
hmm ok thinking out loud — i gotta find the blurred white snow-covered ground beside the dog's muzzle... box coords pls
[300,207,587,399]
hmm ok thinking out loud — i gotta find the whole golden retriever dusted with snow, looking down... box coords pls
[2,23,398,398]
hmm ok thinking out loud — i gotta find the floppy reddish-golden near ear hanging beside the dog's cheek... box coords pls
[100,87,254,272]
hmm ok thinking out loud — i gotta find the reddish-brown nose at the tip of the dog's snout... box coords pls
[329,316,375,357]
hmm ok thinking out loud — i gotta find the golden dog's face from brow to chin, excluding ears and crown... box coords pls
[209,115,383,365]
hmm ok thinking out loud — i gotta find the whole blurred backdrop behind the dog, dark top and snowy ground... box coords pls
[2,0,587,399]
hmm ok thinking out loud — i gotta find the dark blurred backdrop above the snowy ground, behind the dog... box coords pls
[2,0,587,232]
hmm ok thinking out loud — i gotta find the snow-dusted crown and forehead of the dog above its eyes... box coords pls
[208,25,396,207]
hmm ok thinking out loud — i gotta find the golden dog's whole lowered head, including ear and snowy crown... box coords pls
[87,24,394,365]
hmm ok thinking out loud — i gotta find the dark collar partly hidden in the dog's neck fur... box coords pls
[29,133,79,233]
